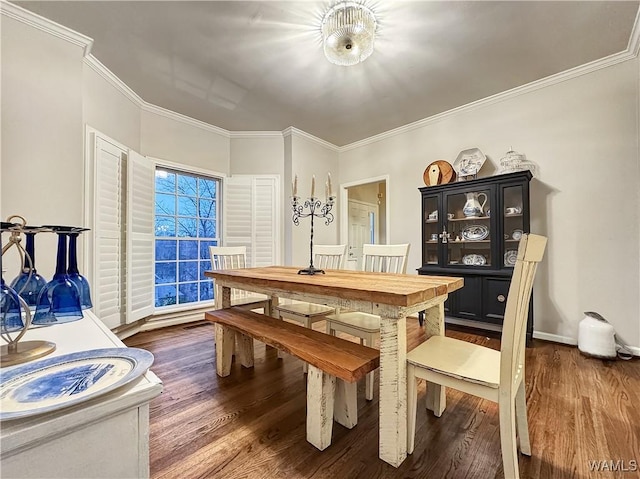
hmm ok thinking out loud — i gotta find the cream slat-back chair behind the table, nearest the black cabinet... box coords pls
[326,244,410,401]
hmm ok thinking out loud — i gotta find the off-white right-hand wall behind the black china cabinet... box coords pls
[340,58,640,346]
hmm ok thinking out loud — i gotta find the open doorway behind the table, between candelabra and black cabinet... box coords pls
[340,177,388,270]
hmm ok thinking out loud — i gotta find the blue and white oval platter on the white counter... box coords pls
[0,348,153,421]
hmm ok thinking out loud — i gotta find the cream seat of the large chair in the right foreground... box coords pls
[407,336,500,389]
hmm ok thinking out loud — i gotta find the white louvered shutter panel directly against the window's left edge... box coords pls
[126,150,155,323]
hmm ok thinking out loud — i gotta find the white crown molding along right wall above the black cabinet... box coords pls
[339,36,640,153]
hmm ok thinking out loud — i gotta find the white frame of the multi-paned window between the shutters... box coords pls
[147,156,227,316]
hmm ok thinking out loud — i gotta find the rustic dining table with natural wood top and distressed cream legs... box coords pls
[205,266,464,467]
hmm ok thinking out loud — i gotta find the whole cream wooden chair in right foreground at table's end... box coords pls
[407,234,547,479]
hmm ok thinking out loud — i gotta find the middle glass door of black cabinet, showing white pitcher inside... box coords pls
[445,189,495,267]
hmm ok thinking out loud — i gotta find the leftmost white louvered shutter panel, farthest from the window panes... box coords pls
[92,137,126,328]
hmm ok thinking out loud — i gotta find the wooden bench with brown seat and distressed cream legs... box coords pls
[205,307,380,451]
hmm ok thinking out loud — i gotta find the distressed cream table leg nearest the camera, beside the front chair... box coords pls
[379,316,407,467]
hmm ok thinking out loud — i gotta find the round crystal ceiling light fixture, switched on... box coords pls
[322,2,376,66]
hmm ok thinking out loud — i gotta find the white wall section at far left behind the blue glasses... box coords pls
[0,15,84,281]
